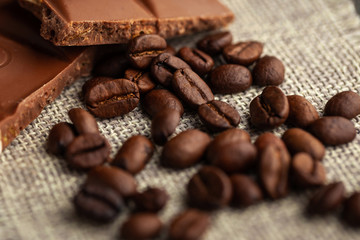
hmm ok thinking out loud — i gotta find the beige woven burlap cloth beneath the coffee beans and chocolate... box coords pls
[0,0,360,240]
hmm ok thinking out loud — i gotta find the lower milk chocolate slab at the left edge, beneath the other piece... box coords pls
[0,0,94,152]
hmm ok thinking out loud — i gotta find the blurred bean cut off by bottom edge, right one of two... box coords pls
[168,209,210,240]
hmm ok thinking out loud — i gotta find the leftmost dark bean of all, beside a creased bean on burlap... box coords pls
[47,122,75,155]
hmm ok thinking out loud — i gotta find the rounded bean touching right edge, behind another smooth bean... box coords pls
[324,91,360,119]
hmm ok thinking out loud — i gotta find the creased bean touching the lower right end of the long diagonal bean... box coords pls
[198,100,241,132]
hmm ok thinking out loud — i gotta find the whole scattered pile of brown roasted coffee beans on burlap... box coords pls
[48,32,360,240]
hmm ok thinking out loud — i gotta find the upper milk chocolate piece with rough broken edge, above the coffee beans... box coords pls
[19,0,234,46]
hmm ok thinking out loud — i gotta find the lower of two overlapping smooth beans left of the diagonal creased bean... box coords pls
[151,108,180,145]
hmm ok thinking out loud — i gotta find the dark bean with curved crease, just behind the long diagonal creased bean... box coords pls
[179,47,214,76]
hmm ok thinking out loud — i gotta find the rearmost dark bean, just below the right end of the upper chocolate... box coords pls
[197,32,232,55]
